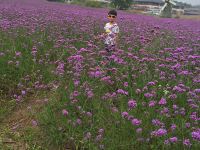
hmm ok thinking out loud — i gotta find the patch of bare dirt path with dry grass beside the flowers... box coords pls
[0,96,47,150]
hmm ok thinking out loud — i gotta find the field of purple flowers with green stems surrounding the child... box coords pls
[0,0,200,150]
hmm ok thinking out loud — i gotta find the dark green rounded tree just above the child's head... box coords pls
[111,0,132,10]
